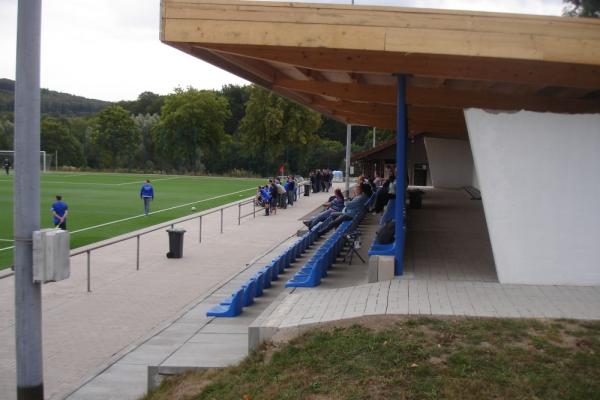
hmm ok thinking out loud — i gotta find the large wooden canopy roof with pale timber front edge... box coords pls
[160,0,600,137]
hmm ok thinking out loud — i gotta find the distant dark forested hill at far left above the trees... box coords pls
[0,78,111,116]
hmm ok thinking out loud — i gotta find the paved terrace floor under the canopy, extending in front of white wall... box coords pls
[251,189,600,342]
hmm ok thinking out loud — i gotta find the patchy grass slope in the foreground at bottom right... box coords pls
[144,317,600,400]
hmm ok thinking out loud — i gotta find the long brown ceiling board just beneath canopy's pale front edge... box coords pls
[202,44,600,89]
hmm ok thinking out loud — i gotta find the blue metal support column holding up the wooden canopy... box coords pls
[394,75,407,275]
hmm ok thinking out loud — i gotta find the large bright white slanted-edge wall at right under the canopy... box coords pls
[465,109,600,285]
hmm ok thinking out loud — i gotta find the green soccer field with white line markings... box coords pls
[0,172,264,269]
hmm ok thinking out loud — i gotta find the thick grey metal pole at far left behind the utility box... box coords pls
[13,0,44,400]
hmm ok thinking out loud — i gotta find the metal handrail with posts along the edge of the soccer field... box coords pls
[70,182,304,292]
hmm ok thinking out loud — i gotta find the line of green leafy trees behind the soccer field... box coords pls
[0,85,391,176]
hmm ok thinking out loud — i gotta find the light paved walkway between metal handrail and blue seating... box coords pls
[0,188,327,400]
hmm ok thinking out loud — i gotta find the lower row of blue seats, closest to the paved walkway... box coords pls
[206,221,327,317]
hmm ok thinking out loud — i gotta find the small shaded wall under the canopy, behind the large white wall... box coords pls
[425,137,473,188]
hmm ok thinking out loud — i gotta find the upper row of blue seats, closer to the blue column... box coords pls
[285,195,374,287]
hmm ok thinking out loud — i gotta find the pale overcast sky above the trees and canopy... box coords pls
[0,0,563,101]
